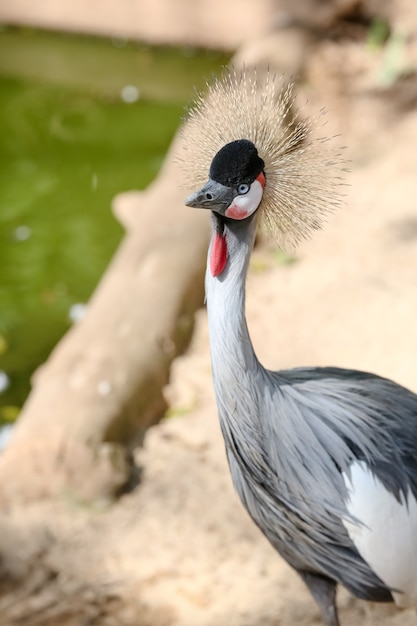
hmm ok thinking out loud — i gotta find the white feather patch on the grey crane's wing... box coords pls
[343,461,417,607]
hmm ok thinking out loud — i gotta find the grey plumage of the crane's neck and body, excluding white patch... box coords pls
[206,213,410,601]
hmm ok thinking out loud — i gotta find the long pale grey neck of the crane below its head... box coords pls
[206,215,262,401]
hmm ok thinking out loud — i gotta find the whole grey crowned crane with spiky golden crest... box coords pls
[179,68,417,626]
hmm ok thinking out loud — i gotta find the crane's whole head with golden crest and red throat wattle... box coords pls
[179,68,344,276]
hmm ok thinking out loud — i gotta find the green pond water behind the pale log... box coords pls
[0,30,227,423]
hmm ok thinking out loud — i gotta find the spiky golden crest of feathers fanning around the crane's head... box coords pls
[180,69,343,249]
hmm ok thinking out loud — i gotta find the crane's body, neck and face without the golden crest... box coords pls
[182,68,417,626]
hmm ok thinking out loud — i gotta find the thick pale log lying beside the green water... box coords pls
[0,136,209,504]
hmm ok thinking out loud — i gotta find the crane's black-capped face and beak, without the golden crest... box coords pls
[185,139,266,220]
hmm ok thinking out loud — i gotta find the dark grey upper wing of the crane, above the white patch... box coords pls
[276,367,417,501]
